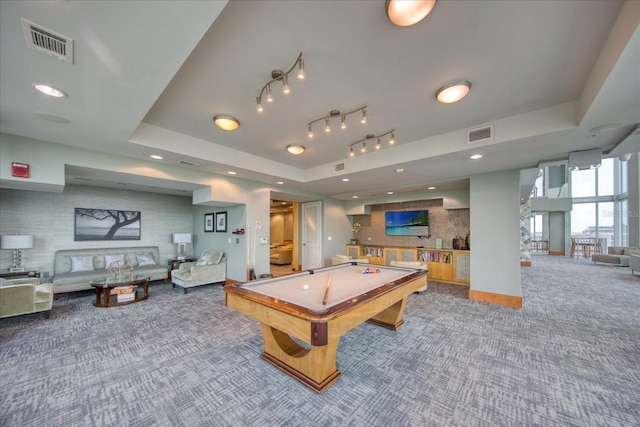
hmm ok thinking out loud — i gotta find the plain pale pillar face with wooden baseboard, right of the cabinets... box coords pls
[470,171,522,297]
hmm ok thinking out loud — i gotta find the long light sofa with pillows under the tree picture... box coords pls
[51,246,169,299]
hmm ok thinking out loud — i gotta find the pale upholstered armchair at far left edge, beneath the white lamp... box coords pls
[0,277,53,319]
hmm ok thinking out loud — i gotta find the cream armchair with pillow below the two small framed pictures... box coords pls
[171,251,227,294]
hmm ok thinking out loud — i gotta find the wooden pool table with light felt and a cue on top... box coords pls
[224,262,427,393]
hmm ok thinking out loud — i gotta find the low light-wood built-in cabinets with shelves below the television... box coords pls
[347,245,471,285]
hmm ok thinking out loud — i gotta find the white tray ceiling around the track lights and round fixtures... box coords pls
[0,0,640,200]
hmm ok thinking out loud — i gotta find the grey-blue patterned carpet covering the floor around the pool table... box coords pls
[0,256,640,426]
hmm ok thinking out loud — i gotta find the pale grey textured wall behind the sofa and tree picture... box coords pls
[0,185,193,280]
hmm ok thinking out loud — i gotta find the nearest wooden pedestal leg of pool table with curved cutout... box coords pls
[260,323,342,393]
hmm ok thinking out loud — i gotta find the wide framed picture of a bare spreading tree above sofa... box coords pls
[73,208,141,242]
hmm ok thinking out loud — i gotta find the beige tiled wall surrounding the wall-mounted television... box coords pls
[353,199,473,249]
